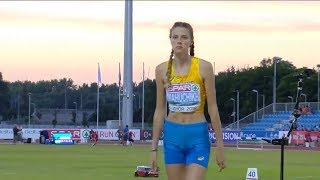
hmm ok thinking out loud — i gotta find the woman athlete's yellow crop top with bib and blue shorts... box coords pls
[163,57,210,168]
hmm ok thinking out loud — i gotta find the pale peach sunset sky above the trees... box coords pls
[0,1,320,85]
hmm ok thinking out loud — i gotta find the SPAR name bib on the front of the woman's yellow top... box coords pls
[166,83,200,112]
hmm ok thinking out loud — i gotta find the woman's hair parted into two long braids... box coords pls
[165,22,194,86]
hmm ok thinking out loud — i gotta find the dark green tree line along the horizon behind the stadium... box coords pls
[0,58,318,124]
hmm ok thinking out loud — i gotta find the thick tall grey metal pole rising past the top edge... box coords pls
[122,0,133,127]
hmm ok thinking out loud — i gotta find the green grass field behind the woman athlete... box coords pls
[0,144,320,180]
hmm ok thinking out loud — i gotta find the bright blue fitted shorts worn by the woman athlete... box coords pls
[163,120,210,168]
